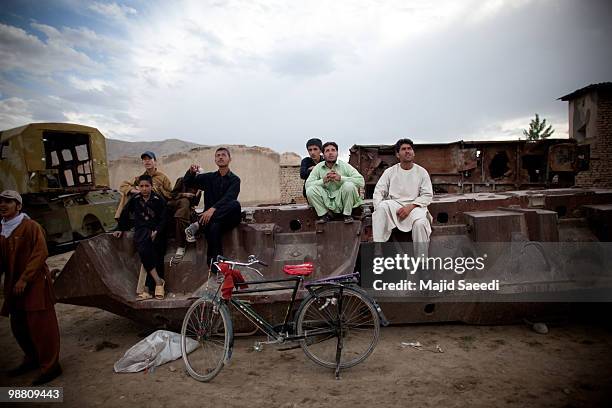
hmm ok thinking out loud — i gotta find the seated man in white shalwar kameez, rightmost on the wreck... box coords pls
[372,139,433,256]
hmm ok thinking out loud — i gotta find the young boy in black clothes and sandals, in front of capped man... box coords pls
[113,174,166,299]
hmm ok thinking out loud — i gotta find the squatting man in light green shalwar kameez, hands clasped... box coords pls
[306,142,365,223]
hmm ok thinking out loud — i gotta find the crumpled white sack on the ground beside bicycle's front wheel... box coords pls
[114,330,198,373]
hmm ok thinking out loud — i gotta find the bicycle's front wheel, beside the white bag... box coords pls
[181,298,234,382]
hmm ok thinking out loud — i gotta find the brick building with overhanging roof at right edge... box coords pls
[559,82,612,187]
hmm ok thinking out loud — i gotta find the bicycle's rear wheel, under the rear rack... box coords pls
[296,287,380,368]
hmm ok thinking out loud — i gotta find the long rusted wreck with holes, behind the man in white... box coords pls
[349,139,588,198]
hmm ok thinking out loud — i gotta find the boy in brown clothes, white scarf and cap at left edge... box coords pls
[0,190,62,385]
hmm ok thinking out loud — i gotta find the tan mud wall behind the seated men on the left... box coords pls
[109,146,280,205]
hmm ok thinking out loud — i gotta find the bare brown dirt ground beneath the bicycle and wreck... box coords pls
[0,253,612,408]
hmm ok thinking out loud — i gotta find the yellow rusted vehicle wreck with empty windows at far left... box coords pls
[0,123,120,252]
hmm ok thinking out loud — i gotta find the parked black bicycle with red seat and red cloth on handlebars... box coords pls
[181,255,382,381]
